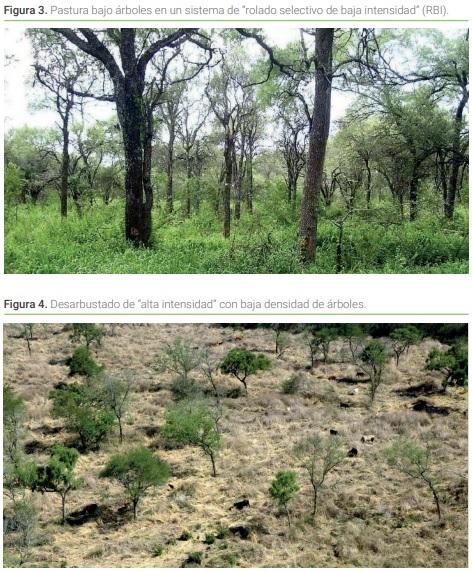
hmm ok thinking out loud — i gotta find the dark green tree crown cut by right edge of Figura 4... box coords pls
[426,342,469,389]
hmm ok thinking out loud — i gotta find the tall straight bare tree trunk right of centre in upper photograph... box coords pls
[300,28,334,263]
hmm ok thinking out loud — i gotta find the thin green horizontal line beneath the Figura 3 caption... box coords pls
[4,17,469,23]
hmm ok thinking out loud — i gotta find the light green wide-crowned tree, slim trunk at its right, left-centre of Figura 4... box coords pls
[161,400,221,477]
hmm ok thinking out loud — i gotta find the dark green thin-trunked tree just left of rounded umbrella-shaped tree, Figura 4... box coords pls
[32,445,83,524]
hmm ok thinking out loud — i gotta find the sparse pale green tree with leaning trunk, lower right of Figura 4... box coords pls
[385,438,442,522]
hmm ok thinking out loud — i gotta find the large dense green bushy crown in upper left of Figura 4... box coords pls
[49,379,115,451]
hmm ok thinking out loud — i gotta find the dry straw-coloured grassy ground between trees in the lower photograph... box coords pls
[4,324,468,568]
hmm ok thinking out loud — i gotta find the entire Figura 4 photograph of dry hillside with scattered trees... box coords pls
[3,323,468,568]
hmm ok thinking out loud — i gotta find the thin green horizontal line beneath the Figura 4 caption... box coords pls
[4,311,468,316]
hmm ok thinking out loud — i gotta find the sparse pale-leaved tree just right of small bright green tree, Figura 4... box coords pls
[294,435,346,519]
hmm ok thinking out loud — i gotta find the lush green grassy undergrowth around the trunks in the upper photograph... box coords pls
[5,200,468,274]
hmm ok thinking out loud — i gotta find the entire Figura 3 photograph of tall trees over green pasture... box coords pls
[4,28,469,274]
